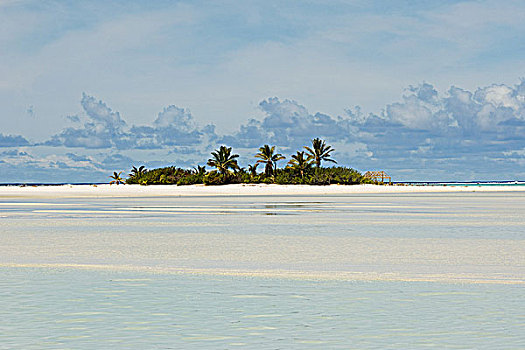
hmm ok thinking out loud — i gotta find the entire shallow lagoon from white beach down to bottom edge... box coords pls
[0,192,525,349]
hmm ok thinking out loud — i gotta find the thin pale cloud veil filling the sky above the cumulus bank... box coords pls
[4,1,525,138]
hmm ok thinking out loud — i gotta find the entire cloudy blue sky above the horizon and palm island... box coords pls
[0,0,525,183]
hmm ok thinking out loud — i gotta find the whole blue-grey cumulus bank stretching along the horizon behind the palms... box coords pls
[4,81,525,180]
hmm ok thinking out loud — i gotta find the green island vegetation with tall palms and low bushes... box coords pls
[123,138,374,185]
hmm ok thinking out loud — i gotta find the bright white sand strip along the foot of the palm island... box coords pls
[0,184,525,198]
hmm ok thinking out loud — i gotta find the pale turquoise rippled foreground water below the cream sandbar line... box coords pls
[0,268,525,349]
